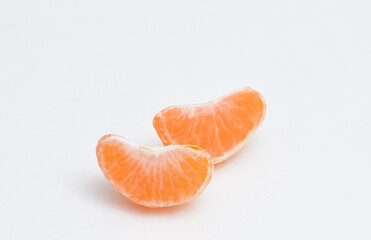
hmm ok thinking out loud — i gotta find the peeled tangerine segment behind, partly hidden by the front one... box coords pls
[153,87,266,163]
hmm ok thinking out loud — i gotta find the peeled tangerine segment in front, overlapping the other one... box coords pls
[97,135,214,208]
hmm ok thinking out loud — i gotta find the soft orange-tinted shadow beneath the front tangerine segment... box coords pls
[81,176,192,215]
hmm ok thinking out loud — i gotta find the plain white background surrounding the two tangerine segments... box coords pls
[0,0,371,240]
